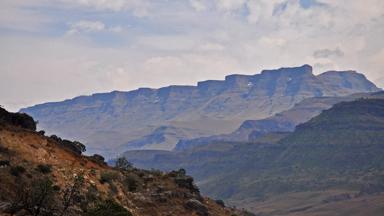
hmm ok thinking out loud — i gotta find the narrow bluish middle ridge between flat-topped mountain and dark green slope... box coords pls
[175,93,378,151]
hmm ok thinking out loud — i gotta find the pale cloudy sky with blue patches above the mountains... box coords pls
[0,0,384,111]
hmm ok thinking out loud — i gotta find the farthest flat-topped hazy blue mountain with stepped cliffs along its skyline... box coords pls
[21,65,378,156]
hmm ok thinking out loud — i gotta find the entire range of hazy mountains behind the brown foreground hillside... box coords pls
[14,65,384,216]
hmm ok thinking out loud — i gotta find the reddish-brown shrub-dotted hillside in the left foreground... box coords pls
[0,108,243,216]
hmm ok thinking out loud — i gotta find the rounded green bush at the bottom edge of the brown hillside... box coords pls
[85,200,132,216]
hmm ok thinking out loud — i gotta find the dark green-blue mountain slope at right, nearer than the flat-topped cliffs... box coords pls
[125,92,384,215]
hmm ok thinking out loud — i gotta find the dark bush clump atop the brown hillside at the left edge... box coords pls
[0,107,36,131]
